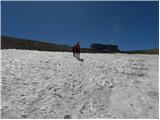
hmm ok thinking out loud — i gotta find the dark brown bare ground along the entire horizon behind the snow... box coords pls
[1,36,159,54]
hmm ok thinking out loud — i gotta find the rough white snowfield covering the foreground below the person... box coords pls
[1,49,159,119]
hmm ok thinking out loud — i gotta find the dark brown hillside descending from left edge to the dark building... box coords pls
[1,36,96,53]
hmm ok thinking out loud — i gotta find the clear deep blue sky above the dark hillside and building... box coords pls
[1,1,159,50]
